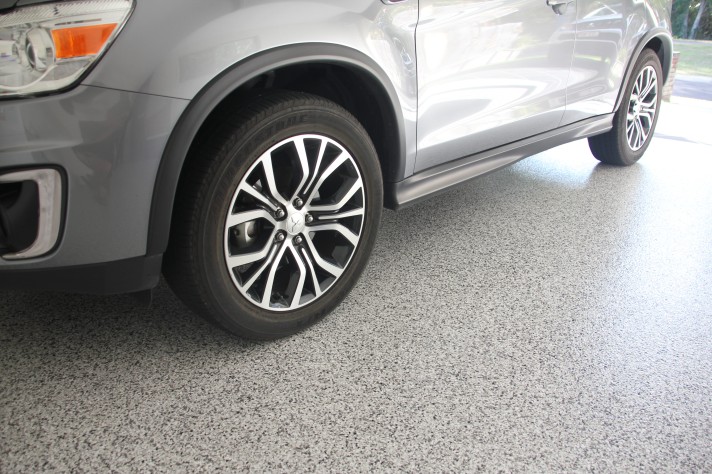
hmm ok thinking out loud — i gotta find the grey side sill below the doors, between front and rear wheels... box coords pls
[384,114,614,210]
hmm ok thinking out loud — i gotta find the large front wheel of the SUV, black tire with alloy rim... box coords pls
[164,92,383,339]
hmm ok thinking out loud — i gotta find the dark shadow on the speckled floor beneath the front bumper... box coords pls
[0,281,260,363]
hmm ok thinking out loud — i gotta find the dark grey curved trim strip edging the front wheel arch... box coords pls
[146,43,406,255]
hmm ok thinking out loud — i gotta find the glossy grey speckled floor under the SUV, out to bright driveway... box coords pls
[0,101,712,473]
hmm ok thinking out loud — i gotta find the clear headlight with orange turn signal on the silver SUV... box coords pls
[0,0,133,98]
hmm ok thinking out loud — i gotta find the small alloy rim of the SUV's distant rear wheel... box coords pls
[626,66,658,151]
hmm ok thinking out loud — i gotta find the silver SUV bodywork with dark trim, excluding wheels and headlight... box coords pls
[0,0,672,338]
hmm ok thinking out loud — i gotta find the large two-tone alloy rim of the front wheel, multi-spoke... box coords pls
[223,134,366,311]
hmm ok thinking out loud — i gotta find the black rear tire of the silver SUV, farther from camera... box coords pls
[588,49,663,166]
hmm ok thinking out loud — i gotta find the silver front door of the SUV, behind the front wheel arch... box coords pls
[415,0,576,172]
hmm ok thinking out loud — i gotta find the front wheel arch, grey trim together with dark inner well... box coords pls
[146,43,406,255]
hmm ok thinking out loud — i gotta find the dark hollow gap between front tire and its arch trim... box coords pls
[187,63,401,185]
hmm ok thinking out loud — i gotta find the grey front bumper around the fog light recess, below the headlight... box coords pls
[0,86,188,293]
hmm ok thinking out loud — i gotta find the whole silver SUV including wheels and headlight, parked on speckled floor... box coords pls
[0,0,672,338]
